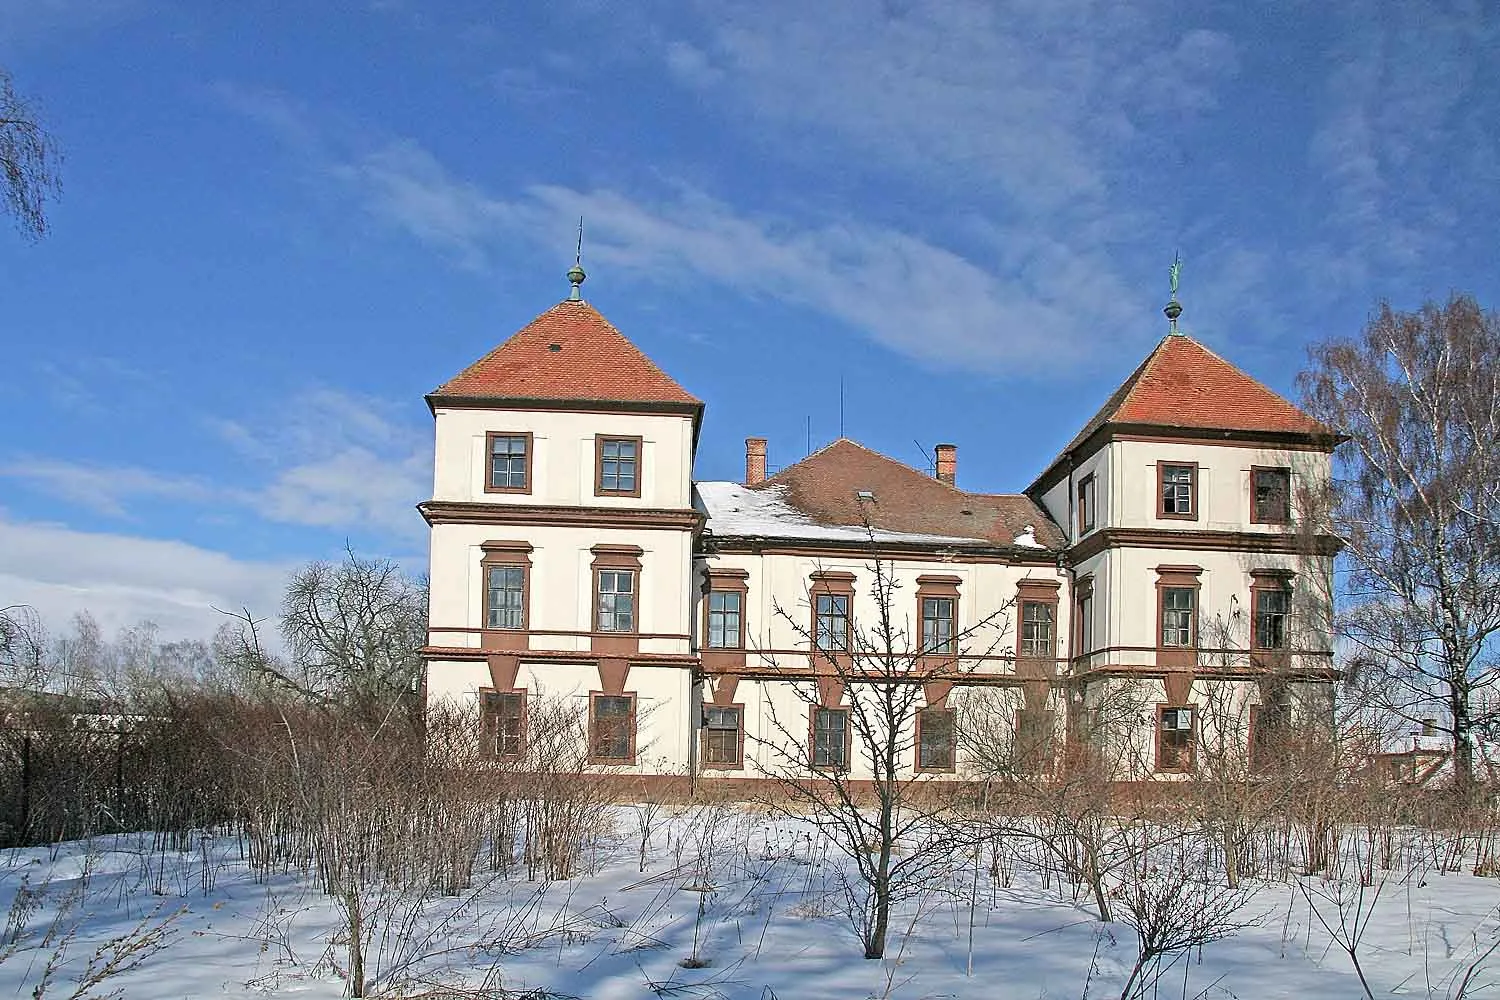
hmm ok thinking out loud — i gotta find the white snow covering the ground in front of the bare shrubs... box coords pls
[0,807,1500,1000]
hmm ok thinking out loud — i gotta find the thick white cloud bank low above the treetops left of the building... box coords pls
[0,511,294,637]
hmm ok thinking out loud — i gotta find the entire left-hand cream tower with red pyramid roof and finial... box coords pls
[419,265,704,771]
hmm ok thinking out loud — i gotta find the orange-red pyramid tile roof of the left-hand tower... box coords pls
[432,300,702,406]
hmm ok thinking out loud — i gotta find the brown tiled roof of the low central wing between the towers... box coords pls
[762,438,1064,549]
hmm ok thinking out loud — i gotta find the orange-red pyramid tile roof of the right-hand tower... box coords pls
[1064,334,1332,451]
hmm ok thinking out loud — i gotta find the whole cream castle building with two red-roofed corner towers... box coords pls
[419,267,1340,786]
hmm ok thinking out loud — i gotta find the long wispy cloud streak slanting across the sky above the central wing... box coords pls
[335,141,1139,375]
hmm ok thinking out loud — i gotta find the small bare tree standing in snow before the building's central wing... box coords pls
[758,558,1011,958]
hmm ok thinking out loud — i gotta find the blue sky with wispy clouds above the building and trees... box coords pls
[0,0,1500,634]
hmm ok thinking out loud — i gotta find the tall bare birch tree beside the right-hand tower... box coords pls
[1301,295,1500,787]
